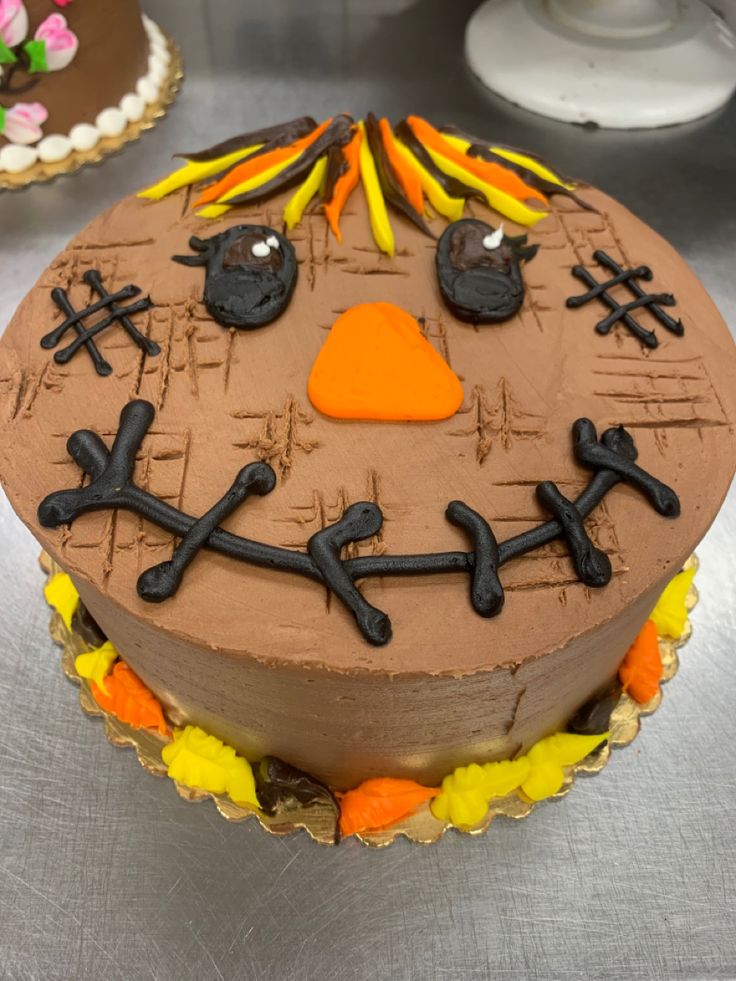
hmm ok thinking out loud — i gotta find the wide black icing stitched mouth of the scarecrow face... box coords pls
[38,399,680,646]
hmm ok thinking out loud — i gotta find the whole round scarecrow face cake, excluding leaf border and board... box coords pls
[0,116,735,820]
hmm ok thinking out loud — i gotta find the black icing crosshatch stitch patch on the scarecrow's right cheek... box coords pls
[566,249,685,348]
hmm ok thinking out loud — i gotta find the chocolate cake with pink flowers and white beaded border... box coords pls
[0,0,170,174]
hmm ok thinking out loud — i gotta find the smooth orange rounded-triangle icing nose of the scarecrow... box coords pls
[308,303,463,422]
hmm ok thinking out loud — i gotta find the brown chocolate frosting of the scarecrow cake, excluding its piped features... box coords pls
[0,180,736,787]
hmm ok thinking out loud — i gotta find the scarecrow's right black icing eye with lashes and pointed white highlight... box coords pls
[436,218,538,324]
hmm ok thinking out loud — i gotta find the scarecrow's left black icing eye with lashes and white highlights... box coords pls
[173,225,297,330]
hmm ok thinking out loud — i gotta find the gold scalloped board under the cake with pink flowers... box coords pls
[0,31,184,191]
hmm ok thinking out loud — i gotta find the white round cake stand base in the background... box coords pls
[465,0,736,129]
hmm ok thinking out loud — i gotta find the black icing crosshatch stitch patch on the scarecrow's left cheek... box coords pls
[41,269,161,376]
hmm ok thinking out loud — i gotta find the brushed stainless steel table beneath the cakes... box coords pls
[0,0,736,981]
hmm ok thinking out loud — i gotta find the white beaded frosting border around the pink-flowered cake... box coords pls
[0,14,171,174]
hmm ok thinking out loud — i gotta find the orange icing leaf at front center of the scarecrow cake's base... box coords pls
[340,777,439,838]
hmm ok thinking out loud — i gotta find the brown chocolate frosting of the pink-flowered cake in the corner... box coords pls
[0,0,148,146]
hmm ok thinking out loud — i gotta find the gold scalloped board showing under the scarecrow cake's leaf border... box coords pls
[40,553,698,848]
